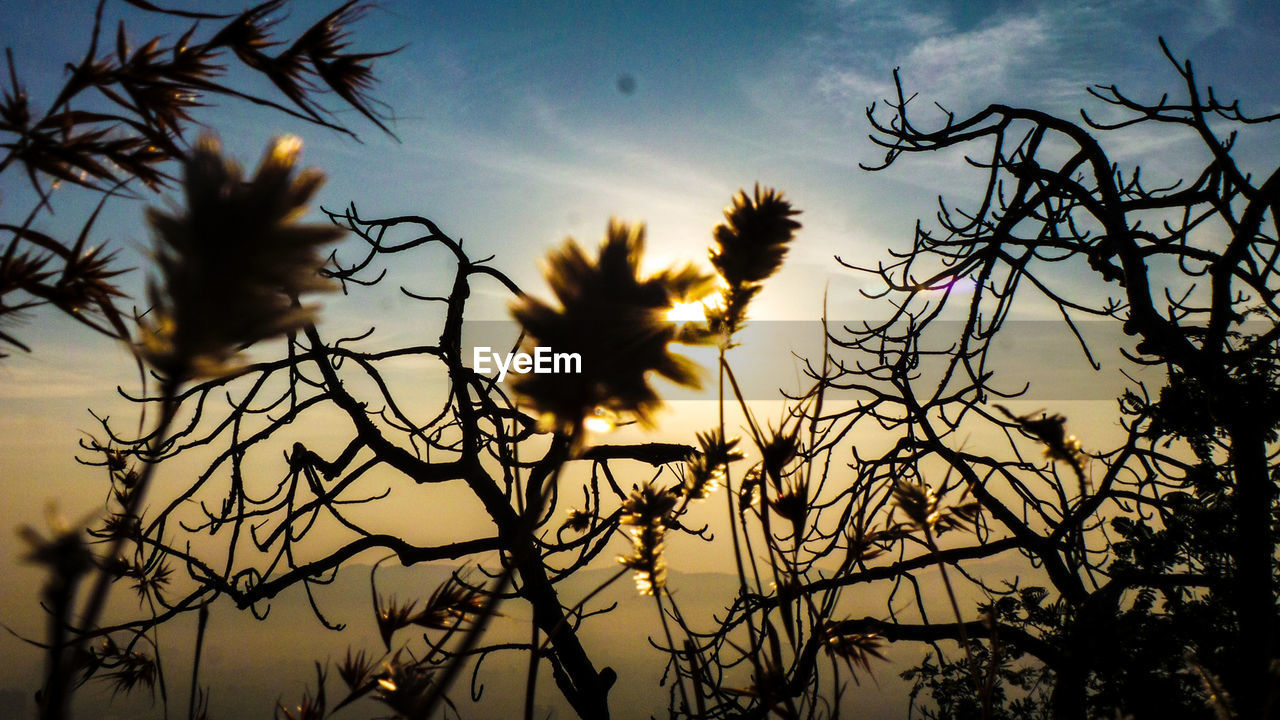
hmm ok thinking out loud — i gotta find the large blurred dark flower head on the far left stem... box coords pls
[138,136,342,379]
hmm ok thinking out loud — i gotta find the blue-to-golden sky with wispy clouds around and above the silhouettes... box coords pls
[0,0,1280,712]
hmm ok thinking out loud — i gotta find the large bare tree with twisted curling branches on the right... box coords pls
[655,37,1280,719]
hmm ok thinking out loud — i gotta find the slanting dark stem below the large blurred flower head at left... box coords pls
[40,378,182,720]
